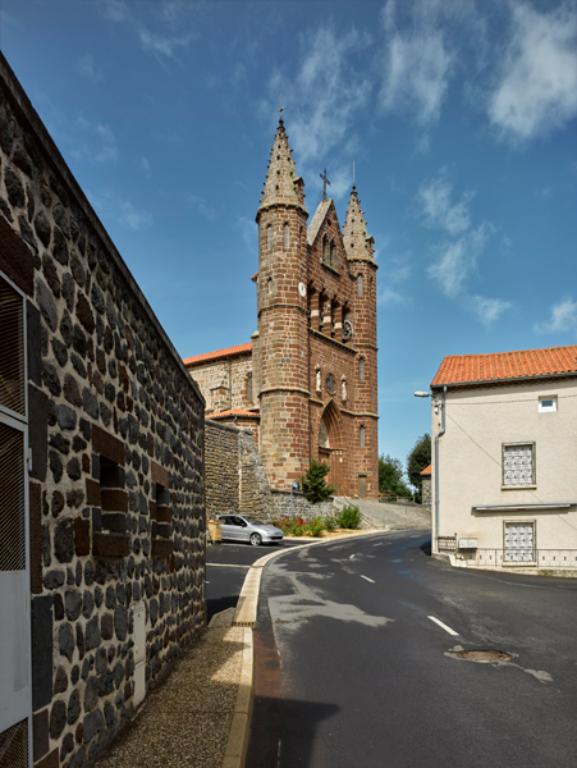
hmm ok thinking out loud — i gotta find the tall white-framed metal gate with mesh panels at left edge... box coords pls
[0,275,31,768]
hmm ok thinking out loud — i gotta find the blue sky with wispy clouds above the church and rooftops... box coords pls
[0,0,577,474]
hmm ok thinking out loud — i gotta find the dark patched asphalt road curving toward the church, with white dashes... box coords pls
[247,534,577,768]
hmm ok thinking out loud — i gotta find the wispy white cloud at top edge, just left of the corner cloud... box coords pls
[380,0,454,125]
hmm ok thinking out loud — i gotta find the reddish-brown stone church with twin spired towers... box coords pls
[184,119,378,497]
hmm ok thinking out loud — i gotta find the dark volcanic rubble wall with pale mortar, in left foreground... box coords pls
[0,57,205,768]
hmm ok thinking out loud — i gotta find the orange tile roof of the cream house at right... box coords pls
[431,345,577,387]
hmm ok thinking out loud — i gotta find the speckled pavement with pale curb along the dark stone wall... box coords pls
[96,609,252,768]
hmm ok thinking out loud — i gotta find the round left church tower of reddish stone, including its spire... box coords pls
[253,118,310,490]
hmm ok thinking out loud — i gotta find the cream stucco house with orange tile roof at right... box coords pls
[431,346,577,570]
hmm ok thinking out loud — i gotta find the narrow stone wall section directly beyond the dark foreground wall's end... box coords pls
[205,419,239,518]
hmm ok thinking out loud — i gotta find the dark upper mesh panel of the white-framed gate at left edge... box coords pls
[0,278,25,415]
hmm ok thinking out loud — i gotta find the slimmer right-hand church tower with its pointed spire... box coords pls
[343,185,378,496]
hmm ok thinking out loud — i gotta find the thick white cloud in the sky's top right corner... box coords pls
[488,2,577,141]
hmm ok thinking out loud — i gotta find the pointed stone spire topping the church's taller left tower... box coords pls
[259,117,305,216]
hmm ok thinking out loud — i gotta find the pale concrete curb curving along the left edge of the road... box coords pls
[222,530,392,768]
